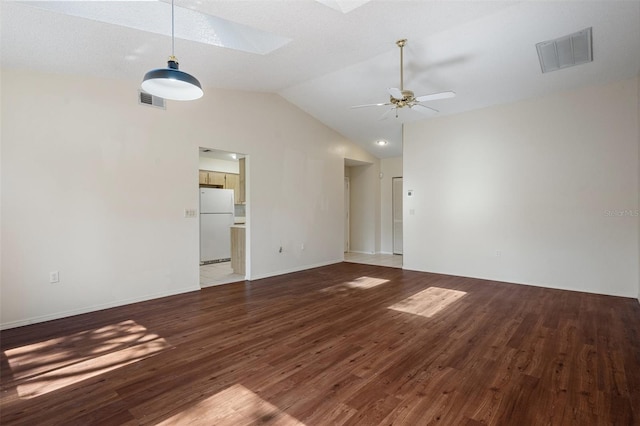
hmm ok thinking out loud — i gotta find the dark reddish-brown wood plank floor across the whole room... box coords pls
[0,263,640,426]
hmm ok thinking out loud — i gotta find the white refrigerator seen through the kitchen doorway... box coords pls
[200,188,233,264]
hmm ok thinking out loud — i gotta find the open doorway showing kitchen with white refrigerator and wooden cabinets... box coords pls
[198,147,249,288]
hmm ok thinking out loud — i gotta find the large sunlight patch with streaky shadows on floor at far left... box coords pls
[5,320,171,398]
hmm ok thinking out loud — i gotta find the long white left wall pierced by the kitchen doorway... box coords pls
[0,70,367,328]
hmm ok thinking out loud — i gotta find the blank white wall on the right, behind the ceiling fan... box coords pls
[404,79,639,297]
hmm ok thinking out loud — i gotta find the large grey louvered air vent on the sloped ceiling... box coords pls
[536,28,593,73]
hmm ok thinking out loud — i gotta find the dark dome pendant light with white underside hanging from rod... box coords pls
[141,0,204,101]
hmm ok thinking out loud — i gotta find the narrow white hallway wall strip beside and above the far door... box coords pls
[380,157,402,253]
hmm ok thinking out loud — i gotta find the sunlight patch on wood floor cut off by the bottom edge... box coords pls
[158,384,305,426]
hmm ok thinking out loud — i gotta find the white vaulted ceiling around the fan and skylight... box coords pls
[0,0,640,158]
